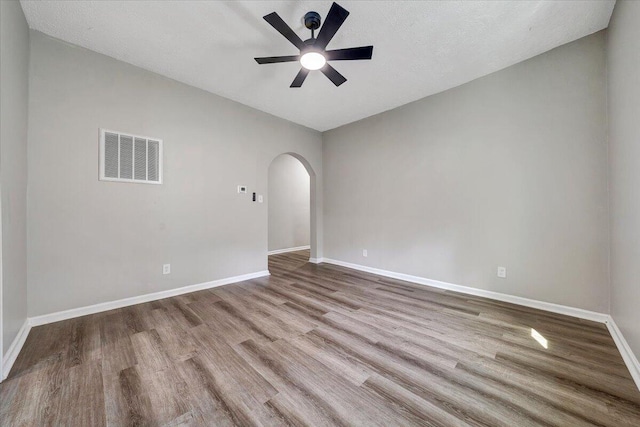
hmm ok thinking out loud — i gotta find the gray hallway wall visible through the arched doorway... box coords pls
[267,154,311,251]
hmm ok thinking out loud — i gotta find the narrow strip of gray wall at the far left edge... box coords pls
[0,1,29,360]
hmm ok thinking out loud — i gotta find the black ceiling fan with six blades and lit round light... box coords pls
[255,3,373,87]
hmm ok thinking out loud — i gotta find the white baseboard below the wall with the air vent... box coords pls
[29,270,269,326]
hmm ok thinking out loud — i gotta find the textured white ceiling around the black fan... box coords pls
[22,0,615,131]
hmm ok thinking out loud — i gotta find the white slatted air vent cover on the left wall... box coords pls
[100,129,162,184]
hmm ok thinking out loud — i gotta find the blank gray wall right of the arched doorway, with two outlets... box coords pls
[323,33,609,312]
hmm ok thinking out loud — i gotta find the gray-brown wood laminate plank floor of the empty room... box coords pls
[0,251,640,427]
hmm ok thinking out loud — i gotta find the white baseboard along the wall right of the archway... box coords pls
[322,258,609,323]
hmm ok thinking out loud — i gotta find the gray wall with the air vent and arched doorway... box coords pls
[28,32,322,316]
